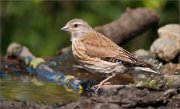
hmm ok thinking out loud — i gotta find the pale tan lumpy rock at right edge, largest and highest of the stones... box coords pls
[150,24,180,62]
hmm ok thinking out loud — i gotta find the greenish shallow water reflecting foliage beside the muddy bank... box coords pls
[0,74,83,104]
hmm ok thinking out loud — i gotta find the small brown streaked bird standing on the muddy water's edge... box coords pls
[61,19,159,92]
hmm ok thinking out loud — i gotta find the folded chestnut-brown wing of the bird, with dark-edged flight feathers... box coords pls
[81,32,152,68]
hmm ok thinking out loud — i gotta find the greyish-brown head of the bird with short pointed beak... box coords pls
[61,19,93,39]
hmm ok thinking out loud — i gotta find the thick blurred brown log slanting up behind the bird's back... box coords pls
[95,8,159,44]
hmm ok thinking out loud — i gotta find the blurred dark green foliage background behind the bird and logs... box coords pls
[0,0,179,57]
